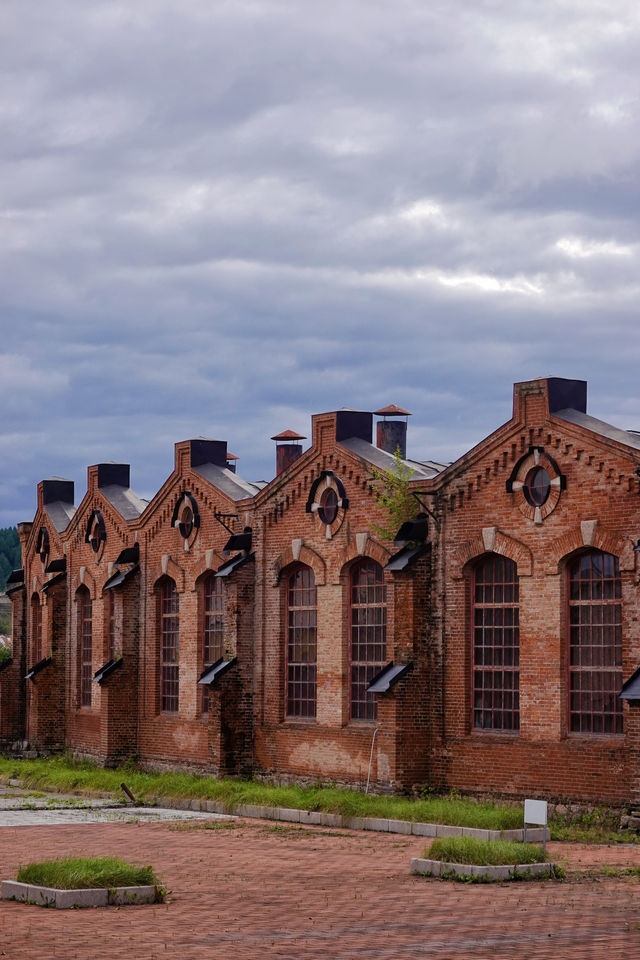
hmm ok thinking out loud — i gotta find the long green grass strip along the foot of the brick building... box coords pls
[0,757,522,830]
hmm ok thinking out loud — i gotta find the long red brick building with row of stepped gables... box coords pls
[0,378,640,805]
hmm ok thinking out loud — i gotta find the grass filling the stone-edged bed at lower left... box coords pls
[16,857,159,890]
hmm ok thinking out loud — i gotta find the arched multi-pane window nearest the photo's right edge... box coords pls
[568,550,622,734]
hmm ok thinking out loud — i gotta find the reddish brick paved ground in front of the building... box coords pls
[0,821,640,960]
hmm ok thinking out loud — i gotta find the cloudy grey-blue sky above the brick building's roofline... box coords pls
[0,0,640,527]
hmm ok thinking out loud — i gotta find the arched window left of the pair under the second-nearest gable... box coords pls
[286,564,317,717]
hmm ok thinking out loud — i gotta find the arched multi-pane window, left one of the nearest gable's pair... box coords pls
[473,553,520,731]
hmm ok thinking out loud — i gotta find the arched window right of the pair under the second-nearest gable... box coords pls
[349,560,387,720]
